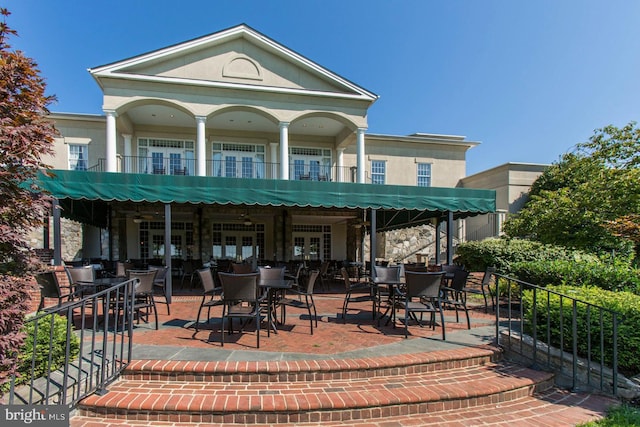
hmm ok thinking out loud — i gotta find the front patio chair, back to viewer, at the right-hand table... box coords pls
[398,271,446,340]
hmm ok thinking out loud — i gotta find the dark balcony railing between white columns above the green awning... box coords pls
[87,156,357,182]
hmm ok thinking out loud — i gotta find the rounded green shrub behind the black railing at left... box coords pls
[5,314,80,387]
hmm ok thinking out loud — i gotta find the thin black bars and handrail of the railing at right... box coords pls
[492,273,622,396]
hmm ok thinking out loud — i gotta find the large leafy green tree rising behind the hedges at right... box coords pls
[504,122,640,260]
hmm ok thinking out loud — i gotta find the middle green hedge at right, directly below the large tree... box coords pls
[511,258,640,295]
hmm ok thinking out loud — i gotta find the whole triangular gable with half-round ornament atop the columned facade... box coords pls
[89,24,378,102]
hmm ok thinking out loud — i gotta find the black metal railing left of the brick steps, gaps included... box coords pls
[6,279,137,408]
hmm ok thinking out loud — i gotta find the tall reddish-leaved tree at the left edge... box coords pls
[0,9,56,392]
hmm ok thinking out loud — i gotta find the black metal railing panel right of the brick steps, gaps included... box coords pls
[492,274,621,396]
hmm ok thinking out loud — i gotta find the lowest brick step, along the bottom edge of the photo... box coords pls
[71,388,616,427]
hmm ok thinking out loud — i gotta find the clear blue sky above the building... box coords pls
[2,0,640,174]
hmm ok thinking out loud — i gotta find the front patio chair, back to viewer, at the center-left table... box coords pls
[218,273,263,348]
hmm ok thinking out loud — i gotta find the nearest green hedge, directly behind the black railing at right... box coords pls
[522,285,640,376]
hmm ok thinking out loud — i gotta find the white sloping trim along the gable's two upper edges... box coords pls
[87,24,379,103]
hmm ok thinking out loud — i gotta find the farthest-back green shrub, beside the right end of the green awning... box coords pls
[456,239,597,274]
